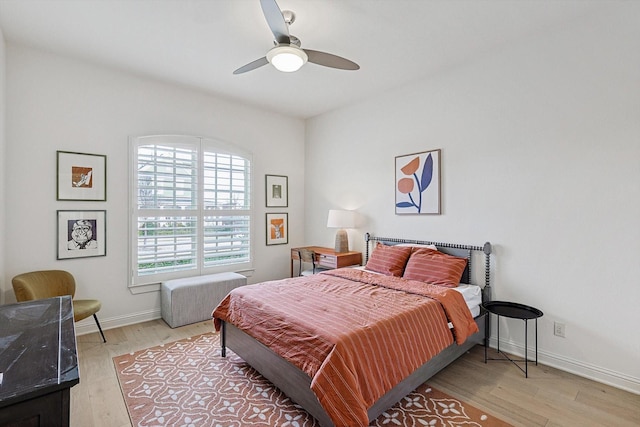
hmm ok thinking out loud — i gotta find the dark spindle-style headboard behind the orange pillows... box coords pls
[364,233,491,301]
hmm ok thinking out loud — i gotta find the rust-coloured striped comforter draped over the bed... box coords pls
[213,268,478,426]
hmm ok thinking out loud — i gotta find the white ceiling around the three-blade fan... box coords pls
[0,0,612,118]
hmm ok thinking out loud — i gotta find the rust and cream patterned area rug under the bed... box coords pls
[113,333,510,427]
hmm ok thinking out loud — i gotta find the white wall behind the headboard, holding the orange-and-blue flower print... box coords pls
[305,2,640,393]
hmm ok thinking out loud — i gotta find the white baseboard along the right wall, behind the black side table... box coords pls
[489,338,640,395]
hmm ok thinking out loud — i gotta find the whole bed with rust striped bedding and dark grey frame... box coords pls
[213,233,491,427]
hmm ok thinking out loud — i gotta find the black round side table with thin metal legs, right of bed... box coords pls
[482,301,543,378]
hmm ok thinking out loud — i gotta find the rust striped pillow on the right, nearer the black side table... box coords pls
[402,249,467,288]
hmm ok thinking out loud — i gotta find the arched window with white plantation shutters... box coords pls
[130,135,252,286]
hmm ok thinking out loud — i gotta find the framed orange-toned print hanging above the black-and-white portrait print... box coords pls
[56,151,107,202]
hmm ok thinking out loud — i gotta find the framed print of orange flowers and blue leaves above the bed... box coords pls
[395,150,440,215]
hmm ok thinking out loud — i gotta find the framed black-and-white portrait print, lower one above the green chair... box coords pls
[58,211,107,259]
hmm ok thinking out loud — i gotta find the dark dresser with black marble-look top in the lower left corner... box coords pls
[0,296,80,427]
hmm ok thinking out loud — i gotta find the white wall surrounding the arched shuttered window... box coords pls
[2,44,304,332]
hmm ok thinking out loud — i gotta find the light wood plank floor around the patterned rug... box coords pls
[71,320,640,427]
